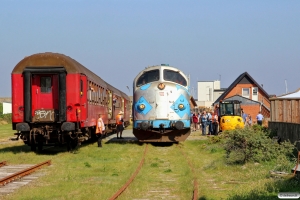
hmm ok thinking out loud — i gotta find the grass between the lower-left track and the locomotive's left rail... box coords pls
[0,143,144,200]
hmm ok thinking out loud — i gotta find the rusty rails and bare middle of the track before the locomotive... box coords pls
[110,145,198,200]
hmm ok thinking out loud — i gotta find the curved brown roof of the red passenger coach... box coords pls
[12,52,106,85]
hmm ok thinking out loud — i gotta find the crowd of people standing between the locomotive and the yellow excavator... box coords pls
[191,108,219,135]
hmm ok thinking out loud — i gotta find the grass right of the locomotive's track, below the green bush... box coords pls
[184,140,300,199]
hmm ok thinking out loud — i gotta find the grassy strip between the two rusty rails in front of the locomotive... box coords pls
[110,143,198,200]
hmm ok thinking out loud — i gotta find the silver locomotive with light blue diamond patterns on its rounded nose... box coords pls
[132,64,191,142]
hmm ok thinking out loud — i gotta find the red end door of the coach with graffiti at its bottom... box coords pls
[31,74,59,122]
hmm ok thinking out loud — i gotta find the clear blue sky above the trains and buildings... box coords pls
[0,0,300,97]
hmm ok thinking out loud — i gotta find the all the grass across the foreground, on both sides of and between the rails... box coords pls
[0,125,300,200]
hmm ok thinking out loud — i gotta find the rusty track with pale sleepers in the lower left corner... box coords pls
[0,160,51,196]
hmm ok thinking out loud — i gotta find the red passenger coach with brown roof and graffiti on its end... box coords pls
[11,53,131,150]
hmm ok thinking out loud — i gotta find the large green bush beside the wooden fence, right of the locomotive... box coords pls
[222,126,295,164]
